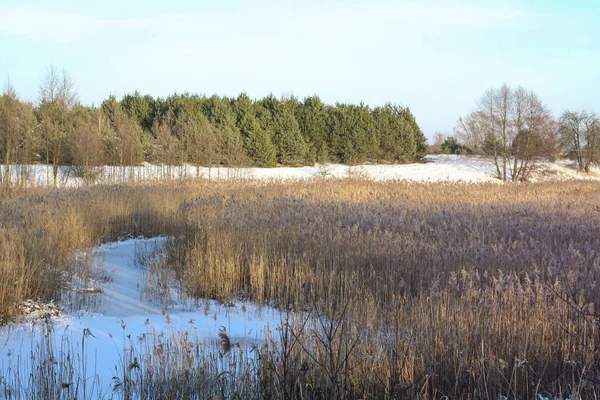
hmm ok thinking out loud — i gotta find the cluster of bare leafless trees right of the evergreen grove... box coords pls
[450,84,600,181]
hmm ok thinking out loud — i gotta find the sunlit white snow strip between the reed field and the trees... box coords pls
[0,155,600,186]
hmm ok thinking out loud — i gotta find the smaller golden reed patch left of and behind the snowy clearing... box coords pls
[0,183,204,322]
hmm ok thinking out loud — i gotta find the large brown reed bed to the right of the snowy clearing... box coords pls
[172,181,600,398]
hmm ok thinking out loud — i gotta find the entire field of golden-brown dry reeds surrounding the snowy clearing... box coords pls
[0,180,600,399]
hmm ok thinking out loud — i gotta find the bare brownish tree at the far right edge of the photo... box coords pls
[558,110,600,172]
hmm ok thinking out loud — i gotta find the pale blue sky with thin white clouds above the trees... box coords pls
[0,0,600,138]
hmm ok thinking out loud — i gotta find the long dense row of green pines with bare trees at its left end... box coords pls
[0,67,427,186]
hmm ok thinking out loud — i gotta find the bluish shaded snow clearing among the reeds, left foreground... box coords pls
[0,237,282,398]
